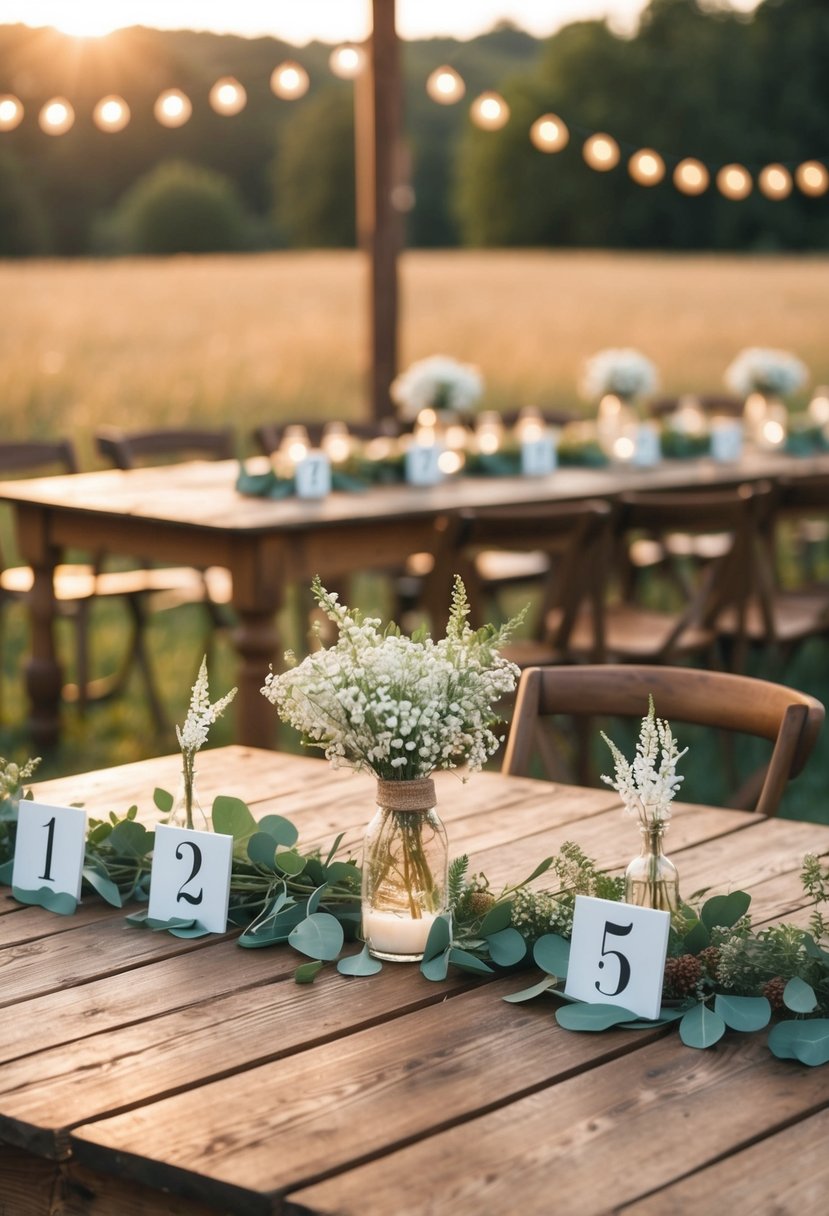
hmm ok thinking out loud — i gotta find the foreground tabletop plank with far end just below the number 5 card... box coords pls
[71,976,666,1216]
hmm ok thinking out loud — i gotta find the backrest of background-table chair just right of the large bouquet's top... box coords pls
[422,499,613,657]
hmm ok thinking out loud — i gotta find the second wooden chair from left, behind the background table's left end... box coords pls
[95,427,235,730]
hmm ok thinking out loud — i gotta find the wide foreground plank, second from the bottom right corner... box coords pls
[286,1031,827,1216]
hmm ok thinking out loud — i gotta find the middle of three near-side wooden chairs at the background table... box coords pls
[561,485,771,666]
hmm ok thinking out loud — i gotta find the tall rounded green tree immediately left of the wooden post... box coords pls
[273,85,356,247]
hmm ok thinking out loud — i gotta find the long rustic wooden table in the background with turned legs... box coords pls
[0,454,829,748]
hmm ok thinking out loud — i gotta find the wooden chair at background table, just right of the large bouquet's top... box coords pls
[421,500,613,666]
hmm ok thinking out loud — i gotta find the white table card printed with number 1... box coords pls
[12,799,86,911]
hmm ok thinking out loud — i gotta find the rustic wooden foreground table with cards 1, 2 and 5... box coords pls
[0,747,829,1216]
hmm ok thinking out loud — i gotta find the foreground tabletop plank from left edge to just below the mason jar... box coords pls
[0,948,474,1156]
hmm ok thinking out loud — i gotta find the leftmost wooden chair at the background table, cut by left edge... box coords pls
[0,439,205,716]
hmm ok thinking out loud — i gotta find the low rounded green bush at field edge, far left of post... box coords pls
[114,161,248,254]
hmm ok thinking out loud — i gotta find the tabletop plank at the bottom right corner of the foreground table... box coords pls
[621,1110,829,1216]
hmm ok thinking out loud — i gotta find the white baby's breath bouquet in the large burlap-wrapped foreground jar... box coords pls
[261,578,520,781]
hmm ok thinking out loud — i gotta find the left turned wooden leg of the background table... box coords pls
[26,554,63,750]
